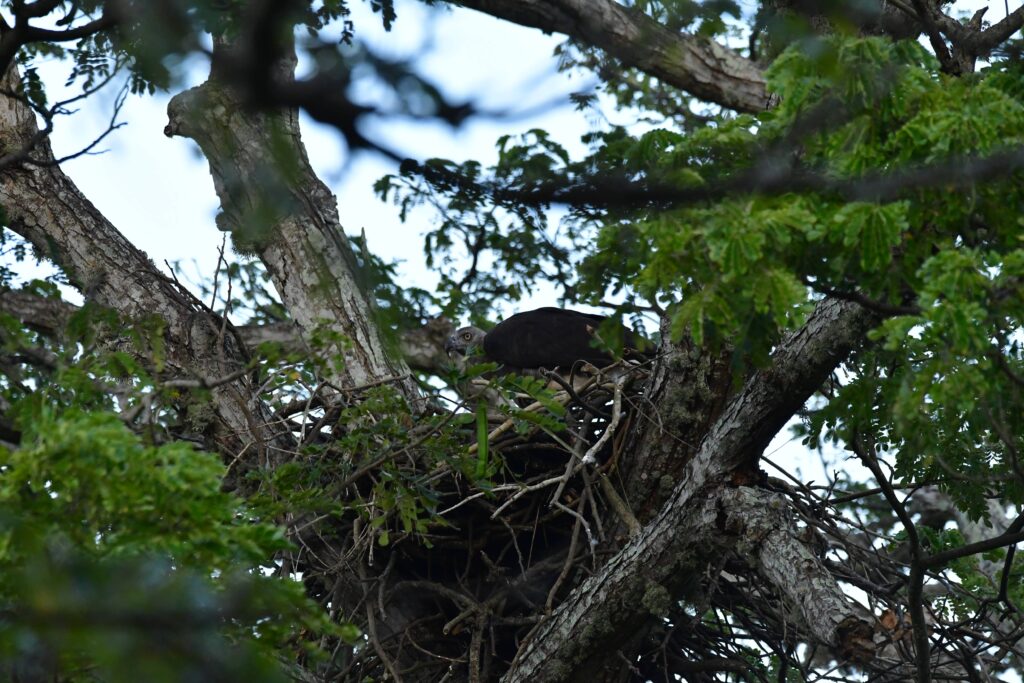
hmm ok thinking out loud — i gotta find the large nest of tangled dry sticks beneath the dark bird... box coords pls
[276,362,648,680]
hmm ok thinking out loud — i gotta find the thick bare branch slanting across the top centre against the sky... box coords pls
[448,0,769,112]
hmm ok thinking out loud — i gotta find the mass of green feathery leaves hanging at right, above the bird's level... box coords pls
[380,39,1024,524]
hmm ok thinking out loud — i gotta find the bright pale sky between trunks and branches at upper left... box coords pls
[32,2,598,313]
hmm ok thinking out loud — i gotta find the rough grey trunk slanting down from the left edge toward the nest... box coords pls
[0,62,293,471]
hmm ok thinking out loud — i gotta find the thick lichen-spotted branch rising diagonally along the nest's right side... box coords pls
[506,300,873,681]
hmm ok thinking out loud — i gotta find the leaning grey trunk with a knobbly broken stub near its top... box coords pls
[165,45,423,409]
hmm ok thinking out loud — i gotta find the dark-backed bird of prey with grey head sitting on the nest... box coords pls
[444,307,640,375]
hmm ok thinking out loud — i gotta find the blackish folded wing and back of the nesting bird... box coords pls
[483,307,628,369]
